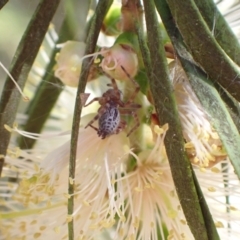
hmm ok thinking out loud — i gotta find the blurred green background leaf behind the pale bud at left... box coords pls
[18,0,90,149]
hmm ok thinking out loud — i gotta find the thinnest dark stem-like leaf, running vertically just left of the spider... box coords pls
[68,0,112,240]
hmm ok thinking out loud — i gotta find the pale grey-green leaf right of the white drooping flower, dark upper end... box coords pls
[155,0,240,180]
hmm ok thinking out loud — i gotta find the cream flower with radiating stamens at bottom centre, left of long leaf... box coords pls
[115,125,193,240]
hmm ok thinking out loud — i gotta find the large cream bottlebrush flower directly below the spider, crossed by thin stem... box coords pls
[0,125,129,240]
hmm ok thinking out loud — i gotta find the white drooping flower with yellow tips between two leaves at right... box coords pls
[170,62,226,167]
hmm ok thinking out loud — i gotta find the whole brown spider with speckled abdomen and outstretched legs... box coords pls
[85,67,141,139]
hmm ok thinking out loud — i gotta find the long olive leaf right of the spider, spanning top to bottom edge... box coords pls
[140,0,208,240]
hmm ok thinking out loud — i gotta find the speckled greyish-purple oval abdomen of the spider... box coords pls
[98,106,120,139]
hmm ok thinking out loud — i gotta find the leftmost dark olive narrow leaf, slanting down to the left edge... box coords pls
[0,0,60,176]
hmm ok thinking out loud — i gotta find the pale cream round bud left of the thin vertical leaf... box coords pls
[54,41,86,87]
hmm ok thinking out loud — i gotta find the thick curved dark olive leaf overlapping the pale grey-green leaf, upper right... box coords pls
[167,0,240,101]
